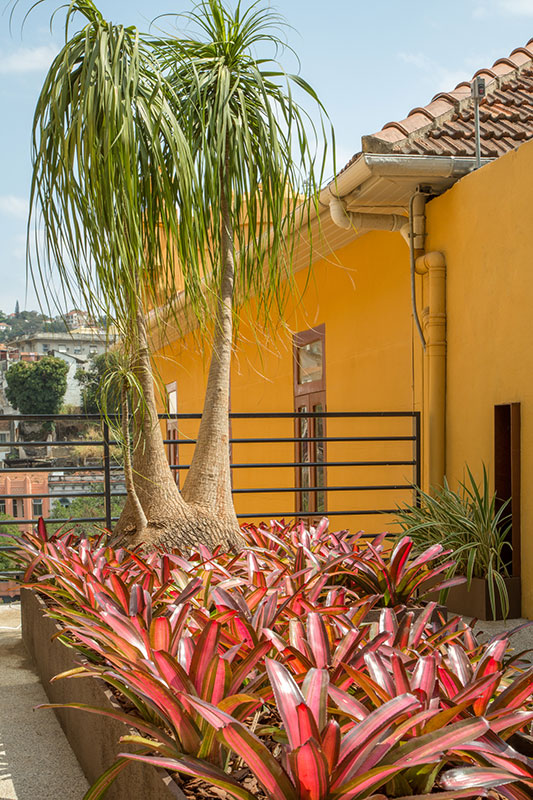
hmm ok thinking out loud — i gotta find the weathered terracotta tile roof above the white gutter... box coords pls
[358,39,533,161]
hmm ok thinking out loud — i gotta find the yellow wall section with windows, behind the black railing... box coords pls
[152,228,413,533]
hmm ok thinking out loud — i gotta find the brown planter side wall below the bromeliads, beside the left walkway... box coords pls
[21,589,186,800]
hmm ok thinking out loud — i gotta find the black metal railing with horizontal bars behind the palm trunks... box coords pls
[0,411,421,575]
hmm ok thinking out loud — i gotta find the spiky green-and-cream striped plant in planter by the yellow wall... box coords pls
[397,465,511,617]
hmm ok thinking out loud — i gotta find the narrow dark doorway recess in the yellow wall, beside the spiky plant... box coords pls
[494,403,521,577]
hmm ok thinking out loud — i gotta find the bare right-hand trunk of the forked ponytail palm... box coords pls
[183,177,239,543]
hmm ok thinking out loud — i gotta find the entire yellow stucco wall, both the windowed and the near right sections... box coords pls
[157,142,533,618]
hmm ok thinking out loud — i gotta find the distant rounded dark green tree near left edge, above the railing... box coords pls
[6,356,68,414]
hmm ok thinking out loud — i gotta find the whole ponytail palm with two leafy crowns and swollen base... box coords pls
[30,0,328,547]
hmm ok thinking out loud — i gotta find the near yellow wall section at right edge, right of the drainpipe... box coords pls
[427,136,533,618]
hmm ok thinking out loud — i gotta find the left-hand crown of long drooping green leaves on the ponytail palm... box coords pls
[28,0,200,340]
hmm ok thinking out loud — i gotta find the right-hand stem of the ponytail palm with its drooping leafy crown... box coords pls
[155,0,326,529]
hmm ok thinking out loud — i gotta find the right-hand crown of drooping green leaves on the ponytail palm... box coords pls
[153,0,327,328]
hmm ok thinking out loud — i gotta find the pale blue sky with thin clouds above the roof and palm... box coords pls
[0,0,533,312]
